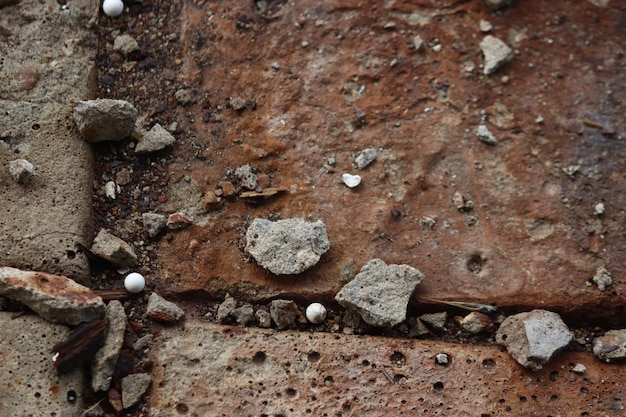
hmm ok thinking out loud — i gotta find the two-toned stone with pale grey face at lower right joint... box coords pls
[496,310,573,371]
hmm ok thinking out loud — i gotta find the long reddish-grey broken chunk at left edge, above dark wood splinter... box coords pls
[0,267,105,326]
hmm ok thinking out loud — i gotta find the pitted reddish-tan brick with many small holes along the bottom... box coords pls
[150,322,626,417]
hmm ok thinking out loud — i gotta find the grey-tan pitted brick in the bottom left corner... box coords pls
[0,312,86,417]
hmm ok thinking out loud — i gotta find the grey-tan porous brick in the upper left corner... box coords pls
[0,0,99,284]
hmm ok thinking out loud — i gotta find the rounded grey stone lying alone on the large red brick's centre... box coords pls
[246,219,330,275]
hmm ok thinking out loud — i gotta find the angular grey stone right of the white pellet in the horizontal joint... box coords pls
[335,259,424,327]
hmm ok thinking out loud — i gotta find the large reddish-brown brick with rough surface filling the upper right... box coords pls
[143,0,626,322]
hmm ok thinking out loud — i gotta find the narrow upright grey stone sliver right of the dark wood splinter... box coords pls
[91,300,126,392]
